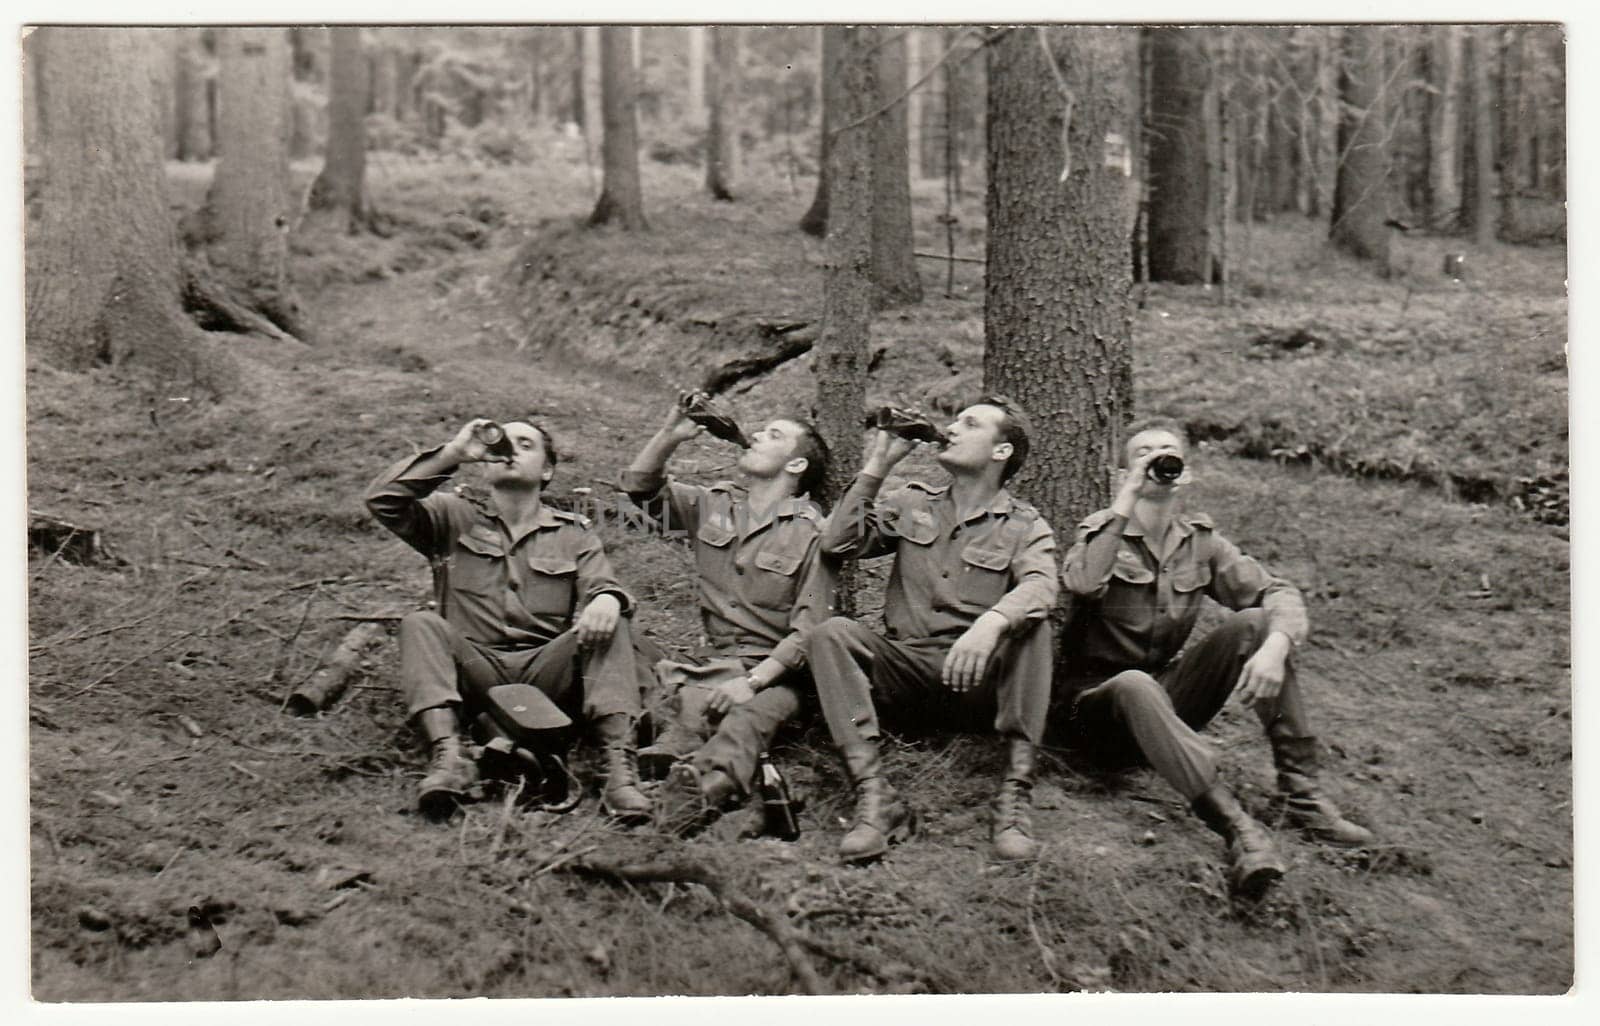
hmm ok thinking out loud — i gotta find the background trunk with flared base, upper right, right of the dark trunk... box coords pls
[1330,26,1389,271]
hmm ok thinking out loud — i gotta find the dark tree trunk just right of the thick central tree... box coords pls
[1144,29,1211,285]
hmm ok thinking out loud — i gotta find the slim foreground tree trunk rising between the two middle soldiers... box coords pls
[813,26,877,608]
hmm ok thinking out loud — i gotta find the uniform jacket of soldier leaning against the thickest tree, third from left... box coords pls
[822,474,1058,639]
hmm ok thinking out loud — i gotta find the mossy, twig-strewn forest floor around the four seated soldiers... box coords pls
[27,148,1574,1002]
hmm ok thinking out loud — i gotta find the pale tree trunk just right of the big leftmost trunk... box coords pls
[206,27,302,335]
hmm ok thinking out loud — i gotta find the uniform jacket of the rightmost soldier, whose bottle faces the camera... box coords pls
[1061,509,1307,674]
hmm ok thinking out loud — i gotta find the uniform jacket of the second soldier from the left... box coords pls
[622,471,835,669]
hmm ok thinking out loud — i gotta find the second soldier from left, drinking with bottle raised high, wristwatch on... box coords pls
[622,394,834,834]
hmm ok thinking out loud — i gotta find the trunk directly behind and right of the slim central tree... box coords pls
[872,26,922,309]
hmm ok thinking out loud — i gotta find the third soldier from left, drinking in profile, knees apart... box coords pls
[808,395,1058,861]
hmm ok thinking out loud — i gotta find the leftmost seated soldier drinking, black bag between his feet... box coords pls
[366,419,650,820]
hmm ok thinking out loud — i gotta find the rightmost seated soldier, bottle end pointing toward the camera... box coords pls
[1053,418,1373,895]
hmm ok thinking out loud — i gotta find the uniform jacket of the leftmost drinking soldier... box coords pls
[366,450,634,648]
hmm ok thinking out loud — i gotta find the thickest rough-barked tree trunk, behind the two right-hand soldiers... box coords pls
[984,27,1133,533]
